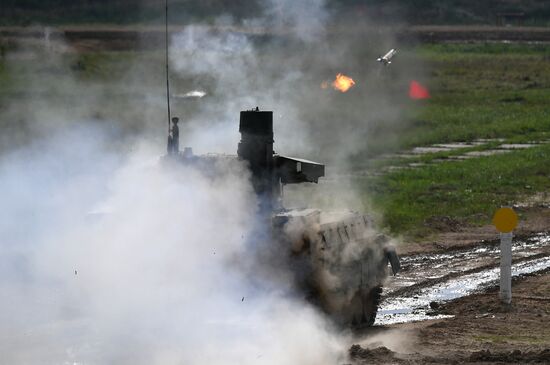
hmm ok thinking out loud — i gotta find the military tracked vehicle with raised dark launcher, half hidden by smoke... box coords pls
[164,108,400,326]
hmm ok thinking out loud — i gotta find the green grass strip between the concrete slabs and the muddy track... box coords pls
[360,141,550,237]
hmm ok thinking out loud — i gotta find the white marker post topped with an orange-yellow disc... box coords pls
[493,207,518,304]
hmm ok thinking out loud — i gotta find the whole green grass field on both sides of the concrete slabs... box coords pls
[358,44,550,237]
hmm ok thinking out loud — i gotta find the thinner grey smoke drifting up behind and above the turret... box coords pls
[170,0,422,165]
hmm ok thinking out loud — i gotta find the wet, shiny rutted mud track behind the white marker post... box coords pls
[375,234,550,325]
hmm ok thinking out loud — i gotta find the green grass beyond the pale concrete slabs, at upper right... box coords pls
[402,44,550,147]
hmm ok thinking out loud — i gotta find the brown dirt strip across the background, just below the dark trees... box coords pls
[0,25,550,51]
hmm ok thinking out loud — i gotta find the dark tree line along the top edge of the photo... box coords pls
[0,0,550,25]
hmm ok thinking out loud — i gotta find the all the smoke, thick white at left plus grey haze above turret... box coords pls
[0,0,422,365]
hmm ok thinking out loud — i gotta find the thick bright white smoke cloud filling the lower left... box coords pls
[0,123,352,364]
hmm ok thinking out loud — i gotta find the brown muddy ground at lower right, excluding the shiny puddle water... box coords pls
[349,203,550,364]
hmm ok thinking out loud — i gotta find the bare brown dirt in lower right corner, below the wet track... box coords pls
[350,271,550,364]
